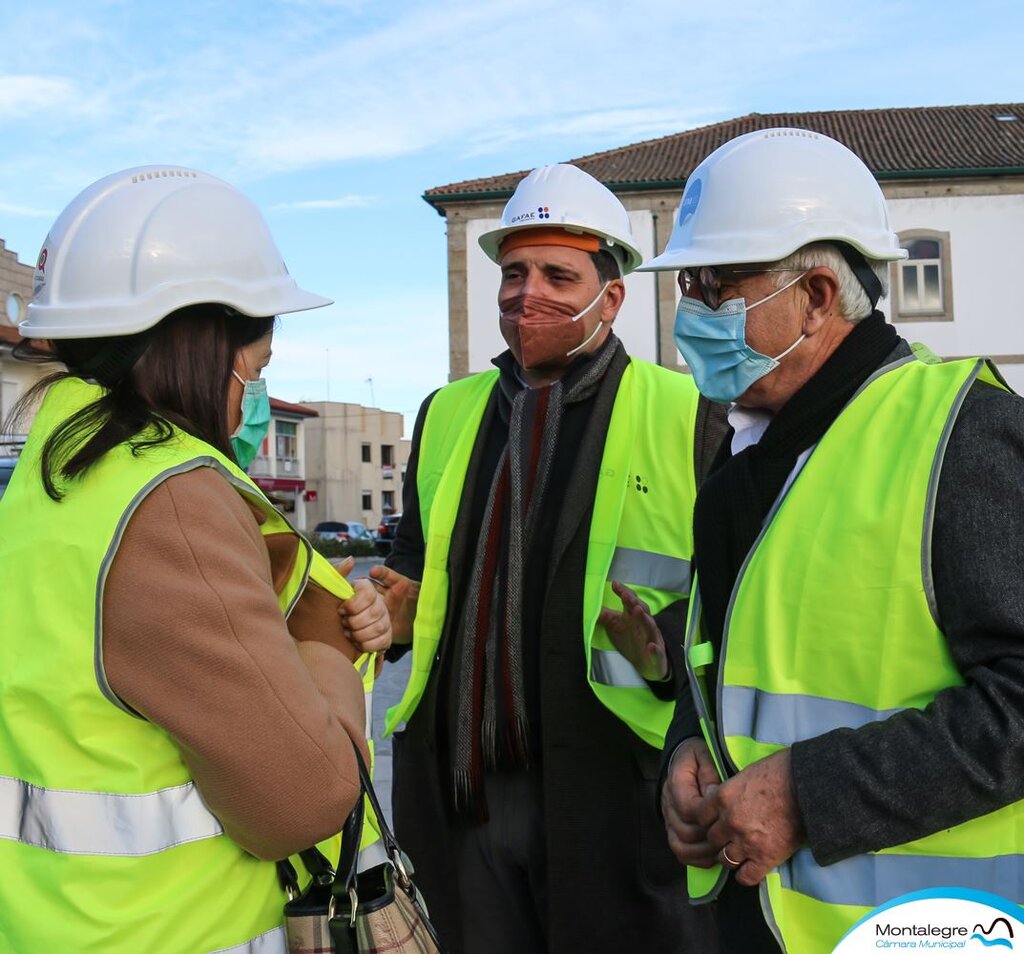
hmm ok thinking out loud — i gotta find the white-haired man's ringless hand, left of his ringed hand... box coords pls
[662,739,719,868]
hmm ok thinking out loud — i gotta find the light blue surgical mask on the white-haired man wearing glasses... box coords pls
[676,272,807,404]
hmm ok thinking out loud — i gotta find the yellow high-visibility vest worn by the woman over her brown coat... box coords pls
[0,378,374,954]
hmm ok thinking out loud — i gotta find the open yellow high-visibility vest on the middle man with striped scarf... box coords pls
[385,360,698,747]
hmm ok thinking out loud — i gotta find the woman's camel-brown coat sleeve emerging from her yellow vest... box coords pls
[101,468,366,860]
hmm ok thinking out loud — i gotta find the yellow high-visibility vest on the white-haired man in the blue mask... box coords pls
[715,358,1024,952]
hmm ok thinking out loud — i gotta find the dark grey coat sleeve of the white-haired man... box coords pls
[792,384,1024,865]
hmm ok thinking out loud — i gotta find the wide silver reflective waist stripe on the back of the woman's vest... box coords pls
[0,776,224,857]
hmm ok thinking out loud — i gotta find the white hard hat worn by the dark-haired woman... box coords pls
[19,166,331,338]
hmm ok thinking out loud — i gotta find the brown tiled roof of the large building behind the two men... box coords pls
[423,102,1024,205]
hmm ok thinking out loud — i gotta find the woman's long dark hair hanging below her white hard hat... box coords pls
[10,304,275,501]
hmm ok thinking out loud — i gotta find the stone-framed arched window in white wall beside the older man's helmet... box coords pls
[892,228,953,321]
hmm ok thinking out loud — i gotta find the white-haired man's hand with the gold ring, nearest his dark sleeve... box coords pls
[697,749,804,884]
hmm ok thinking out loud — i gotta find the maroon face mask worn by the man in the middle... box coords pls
[499,283,608,370]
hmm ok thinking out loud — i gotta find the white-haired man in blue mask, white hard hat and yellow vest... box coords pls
[644,129,1024,954]
